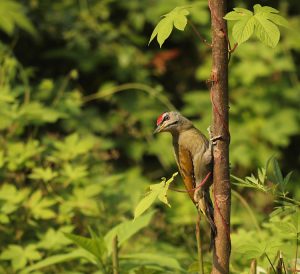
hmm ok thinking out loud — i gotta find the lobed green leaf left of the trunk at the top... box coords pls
[148,7,189,47]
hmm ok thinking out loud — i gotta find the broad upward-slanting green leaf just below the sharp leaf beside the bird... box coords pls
[104,211,154,254]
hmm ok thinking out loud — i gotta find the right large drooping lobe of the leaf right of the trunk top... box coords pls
[254,14,280,48]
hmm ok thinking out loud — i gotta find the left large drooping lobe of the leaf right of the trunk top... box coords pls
[232,16,255,44]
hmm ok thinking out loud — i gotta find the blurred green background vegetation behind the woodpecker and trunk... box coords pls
[0,0,300,273]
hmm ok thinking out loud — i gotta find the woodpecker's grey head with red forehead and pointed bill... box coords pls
[154,111,192,134]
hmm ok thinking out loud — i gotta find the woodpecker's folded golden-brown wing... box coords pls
[175,146,196,201]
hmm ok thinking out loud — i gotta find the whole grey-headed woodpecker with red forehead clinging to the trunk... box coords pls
[154,111,217,247]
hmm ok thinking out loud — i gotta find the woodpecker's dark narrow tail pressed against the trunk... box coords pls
[198,189,217,250]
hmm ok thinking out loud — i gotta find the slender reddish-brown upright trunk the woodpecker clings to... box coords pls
[208,0,231,274]
